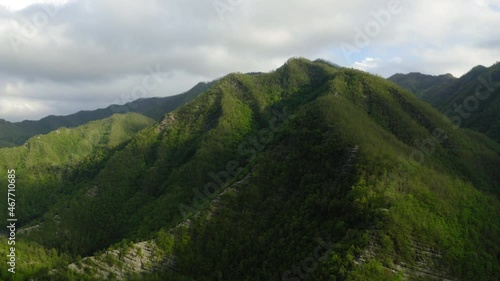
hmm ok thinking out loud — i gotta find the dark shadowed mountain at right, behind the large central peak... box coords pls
[389,63,500,142]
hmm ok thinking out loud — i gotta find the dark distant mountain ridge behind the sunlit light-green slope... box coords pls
[0,82,213,148]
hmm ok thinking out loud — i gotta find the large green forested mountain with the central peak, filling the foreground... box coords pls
[0,58,500,280]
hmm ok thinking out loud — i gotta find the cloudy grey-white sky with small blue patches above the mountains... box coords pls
[0,0,500,121]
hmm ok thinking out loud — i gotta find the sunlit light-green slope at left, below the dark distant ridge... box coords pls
[0,113,154,228]
